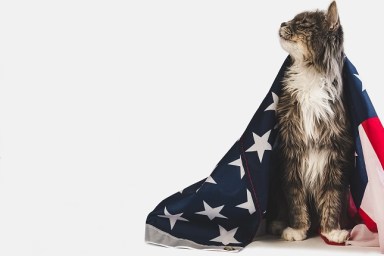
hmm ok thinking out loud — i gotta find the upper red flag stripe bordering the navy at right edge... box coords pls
[362,117,384,169]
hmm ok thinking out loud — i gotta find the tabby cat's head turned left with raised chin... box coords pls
[279,1,344,72]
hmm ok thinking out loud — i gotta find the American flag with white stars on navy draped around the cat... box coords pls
[145,57,384,251]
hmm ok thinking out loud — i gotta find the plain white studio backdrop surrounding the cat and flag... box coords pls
[0,0,384,256]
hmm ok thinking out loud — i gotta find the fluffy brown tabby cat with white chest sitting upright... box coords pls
[270,1,354,243]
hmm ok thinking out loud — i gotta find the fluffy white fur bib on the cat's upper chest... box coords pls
[284,66,338,141]
